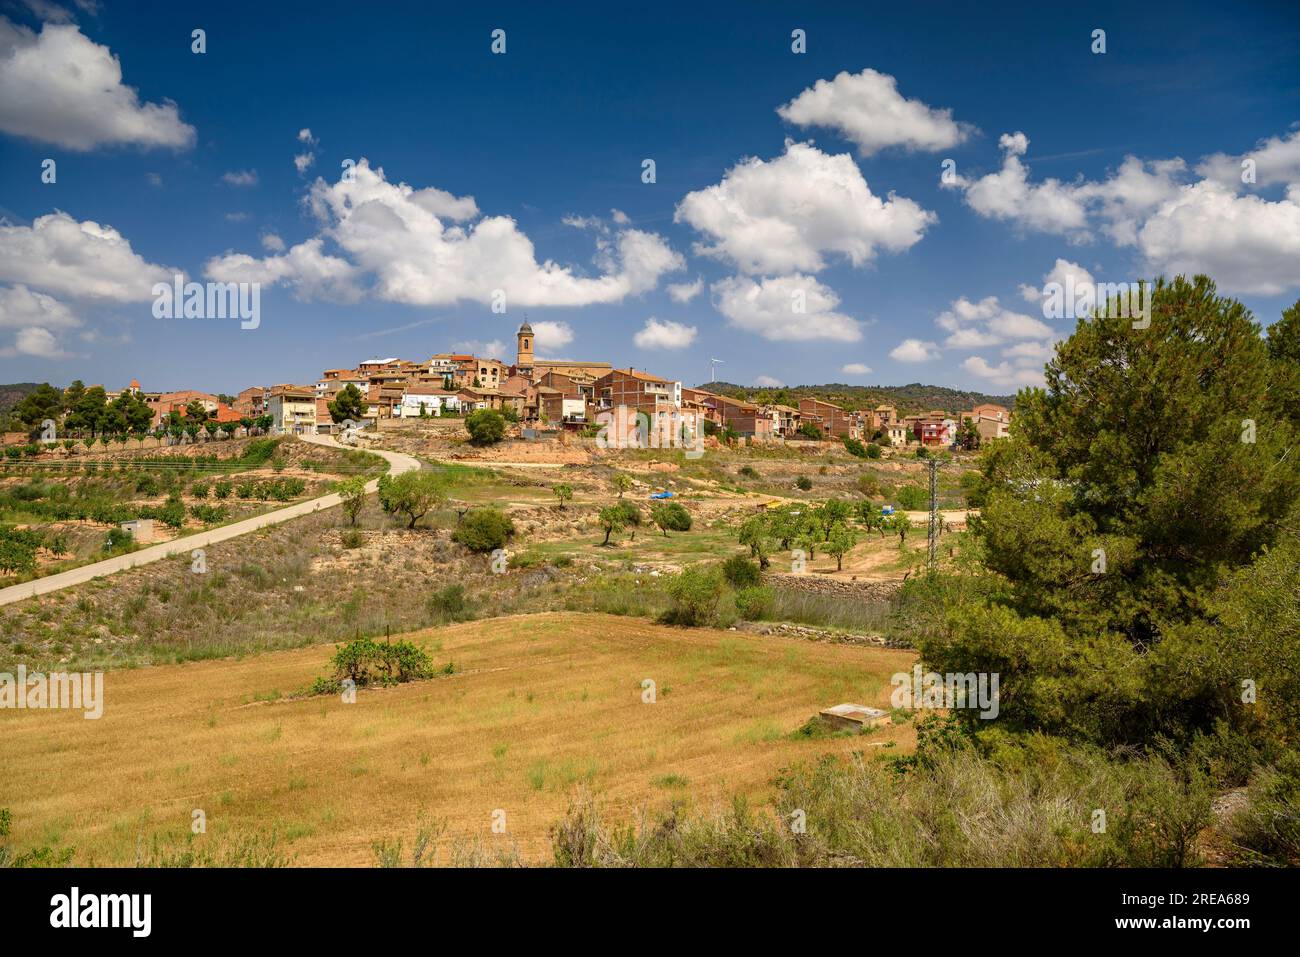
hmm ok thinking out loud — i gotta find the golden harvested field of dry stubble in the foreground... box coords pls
[0,614,914,866]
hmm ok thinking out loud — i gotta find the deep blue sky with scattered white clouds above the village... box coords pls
[0,0,1300,393]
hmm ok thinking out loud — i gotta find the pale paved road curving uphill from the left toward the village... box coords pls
[0,436,420,605]
